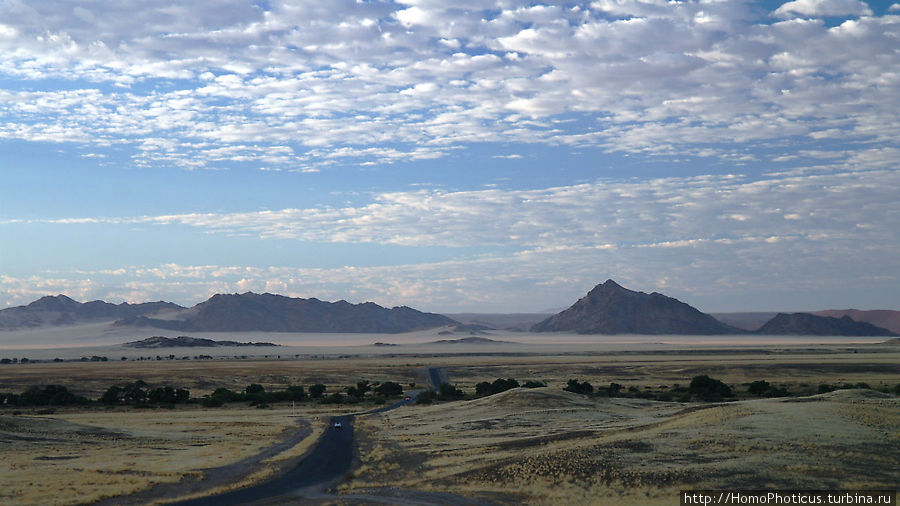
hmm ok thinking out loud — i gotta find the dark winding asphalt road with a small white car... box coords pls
[166,367,446,506]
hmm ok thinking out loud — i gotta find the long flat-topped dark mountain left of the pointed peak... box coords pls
[115,292,457,333]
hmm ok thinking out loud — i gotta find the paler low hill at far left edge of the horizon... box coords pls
[0,295,184,330]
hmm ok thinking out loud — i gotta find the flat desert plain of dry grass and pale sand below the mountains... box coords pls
[0,332,900,504]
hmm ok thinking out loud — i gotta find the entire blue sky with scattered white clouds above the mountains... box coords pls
[0,0,900,312]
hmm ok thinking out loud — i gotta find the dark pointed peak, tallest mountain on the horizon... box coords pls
[531,279,746,335]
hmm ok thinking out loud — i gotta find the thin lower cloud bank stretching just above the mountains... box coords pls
[0,162,900,311]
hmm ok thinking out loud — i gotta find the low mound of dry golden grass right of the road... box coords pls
[342,389,900,504]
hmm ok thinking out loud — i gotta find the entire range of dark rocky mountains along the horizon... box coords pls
[0,279,900,336]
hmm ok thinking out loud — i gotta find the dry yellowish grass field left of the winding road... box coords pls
[0,407,352,504]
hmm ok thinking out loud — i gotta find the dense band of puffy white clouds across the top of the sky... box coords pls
[0,0,900,170]
